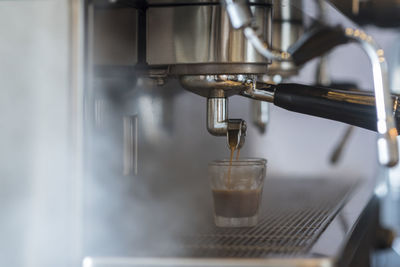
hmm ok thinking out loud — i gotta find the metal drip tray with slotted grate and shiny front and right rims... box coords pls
[84,178,372,267]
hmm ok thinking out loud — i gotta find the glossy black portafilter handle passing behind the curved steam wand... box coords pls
[273,83,400,131]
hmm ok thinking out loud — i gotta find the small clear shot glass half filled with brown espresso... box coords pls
[208,158,267,227]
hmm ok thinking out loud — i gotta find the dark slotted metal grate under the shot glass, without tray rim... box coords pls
[183,179,354,258]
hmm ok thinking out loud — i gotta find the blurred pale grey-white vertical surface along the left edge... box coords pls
[0,0,75,266]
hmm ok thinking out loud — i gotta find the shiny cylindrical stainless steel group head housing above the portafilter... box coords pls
[146,0,272,75]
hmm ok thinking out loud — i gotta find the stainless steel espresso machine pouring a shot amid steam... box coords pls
[80,0,400,267]
